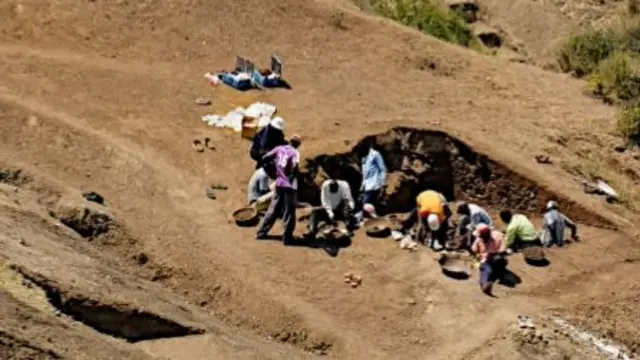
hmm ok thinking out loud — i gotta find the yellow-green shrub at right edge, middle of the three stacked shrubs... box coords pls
[589,51,640,103]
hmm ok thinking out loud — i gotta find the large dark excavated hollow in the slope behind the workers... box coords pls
[299,127,615,229]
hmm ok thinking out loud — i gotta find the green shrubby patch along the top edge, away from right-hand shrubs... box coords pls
[371,0,475,47]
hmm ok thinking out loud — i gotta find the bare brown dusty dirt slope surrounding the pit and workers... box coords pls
[0,0,640,360]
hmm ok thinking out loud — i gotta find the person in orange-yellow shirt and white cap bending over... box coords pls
[400,190,452,251]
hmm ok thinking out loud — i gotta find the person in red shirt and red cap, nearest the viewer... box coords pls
[471,224,507,295]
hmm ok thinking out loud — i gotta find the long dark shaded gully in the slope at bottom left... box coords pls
[16,268,204,342]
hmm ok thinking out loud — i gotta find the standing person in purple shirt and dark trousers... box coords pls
[256,135,302,245]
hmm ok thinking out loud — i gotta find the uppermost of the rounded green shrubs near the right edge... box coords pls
[558,29,622,77]
